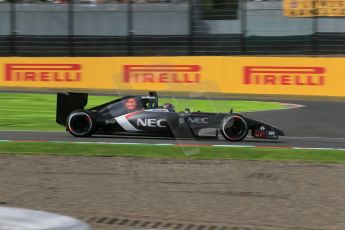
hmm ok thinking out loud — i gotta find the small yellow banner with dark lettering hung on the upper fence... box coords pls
[283,0,345,17]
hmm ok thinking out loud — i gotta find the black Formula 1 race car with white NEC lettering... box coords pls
[56,92,284,141]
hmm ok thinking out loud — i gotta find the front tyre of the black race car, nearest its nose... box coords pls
[220,115,248,141]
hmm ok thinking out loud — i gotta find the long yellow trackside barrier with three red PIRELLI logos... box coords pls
[0,56,345,96]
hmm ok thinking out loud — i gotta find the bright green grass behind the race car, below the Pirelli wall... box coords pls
[0,93,284,130]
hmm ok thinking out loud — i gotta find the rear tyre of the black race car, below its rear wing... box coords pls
[66,110,95,137]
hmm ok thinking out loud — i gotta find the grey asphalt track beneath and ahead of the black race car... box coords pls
[0,100,345,148]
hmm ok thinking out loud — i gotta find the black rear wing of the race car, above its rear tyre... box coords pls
[56,93,88,125]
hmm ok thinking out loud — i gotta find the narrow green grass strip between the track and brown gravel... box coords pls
[0,142,345,163]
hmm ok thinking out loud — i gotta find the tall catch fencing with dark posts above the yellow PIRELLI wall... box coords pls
[0,0,345,56]
